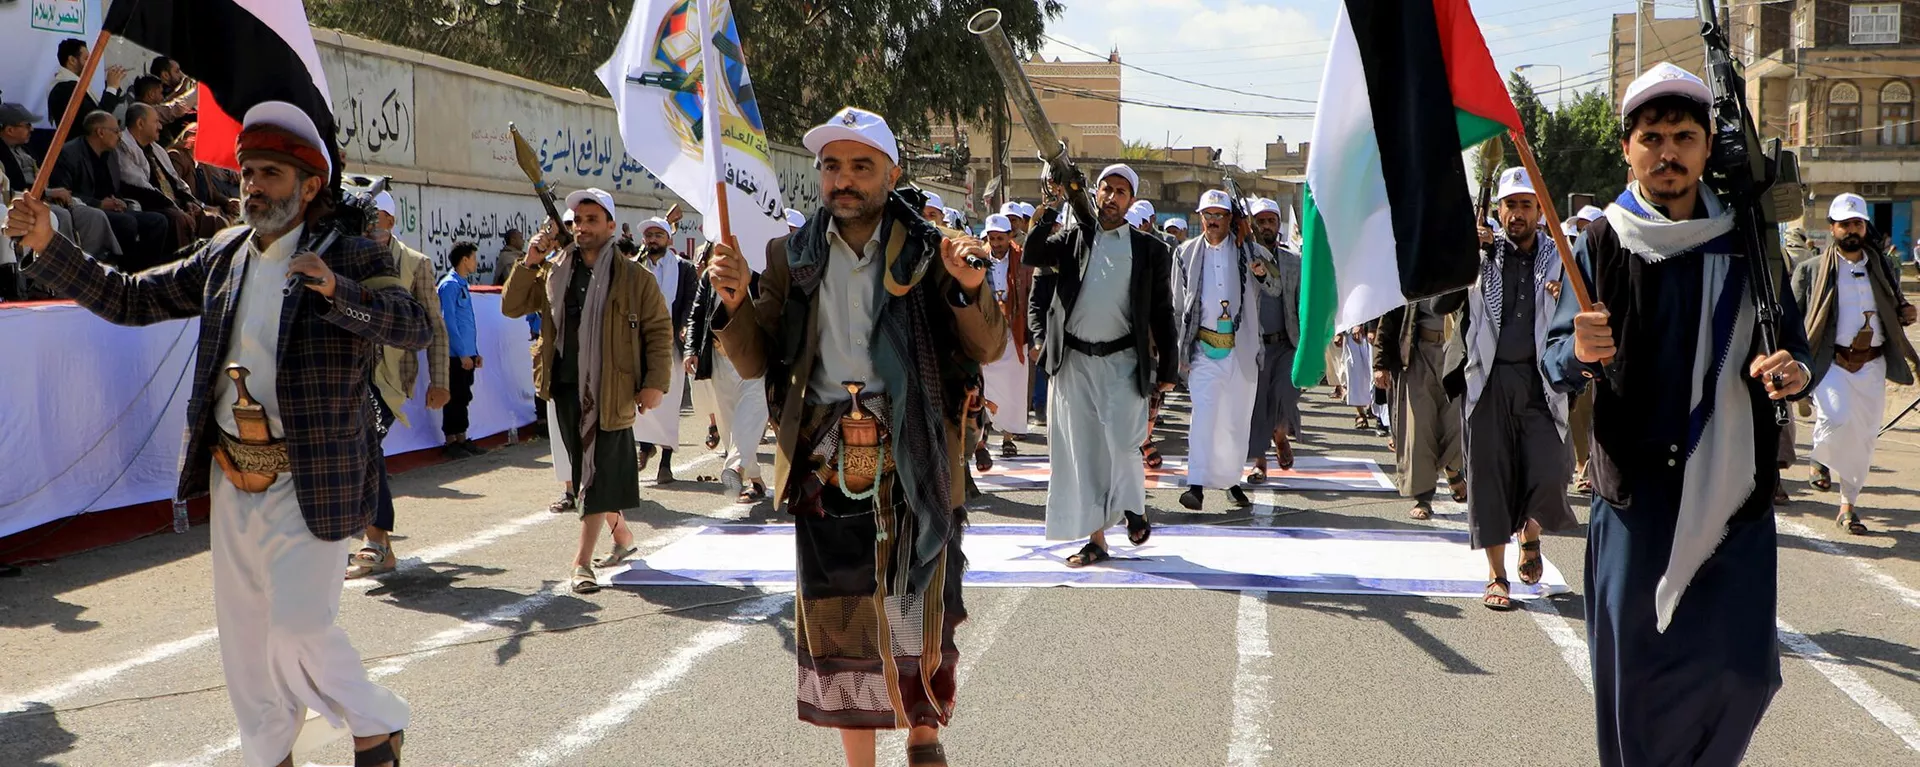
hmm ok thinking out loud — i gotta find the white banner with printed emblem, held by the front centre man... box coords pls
[597,0,787,269]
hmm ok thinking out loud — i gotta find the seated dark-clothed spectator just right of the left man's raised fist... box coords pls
[48,111,171,273]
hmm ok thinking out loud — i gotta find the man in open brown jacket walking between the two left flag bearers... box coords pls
[499,188,680,594]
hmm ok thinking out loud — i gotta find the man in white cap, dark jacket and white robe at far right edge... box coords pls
[1793,192,1920,534]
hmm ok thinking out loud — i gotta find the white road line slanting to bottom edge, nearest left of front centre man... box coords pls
[515,594,793,767]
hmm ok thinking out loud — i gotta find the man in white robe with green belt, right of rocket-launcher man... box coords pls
[1173,188,1281,511]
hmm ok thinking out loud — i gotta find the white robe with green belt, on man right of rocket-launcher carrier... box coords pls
[1175,240,1260,488]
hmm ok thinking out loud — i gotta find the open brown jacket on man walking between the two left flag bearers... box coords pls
[499,247,680,431]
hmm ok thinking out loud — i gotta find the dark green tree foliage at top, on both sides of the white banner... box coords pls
[307,0,1064,144]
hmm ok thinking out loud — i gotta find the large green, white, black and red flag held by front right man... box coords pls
[1294,0,1521,386]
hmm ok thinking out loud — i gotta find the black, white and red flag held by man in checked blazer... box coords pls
[104,0,342,186]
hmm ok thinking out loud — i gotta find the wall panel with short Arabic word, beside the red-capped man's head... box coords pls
[321,48,417,167]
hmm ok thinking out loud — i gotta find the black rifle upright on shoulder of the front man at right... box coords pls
[1699,0,1799,427]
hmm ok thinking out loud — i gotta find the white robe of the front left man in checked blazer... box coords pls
[209,229,409,767]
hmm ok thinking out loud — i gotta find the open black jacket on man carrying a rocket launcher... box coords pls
[1021,203,1181,396]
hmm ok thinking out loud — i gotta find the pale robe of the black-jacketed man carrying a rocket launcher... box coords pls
[1046,227,1146,540]
